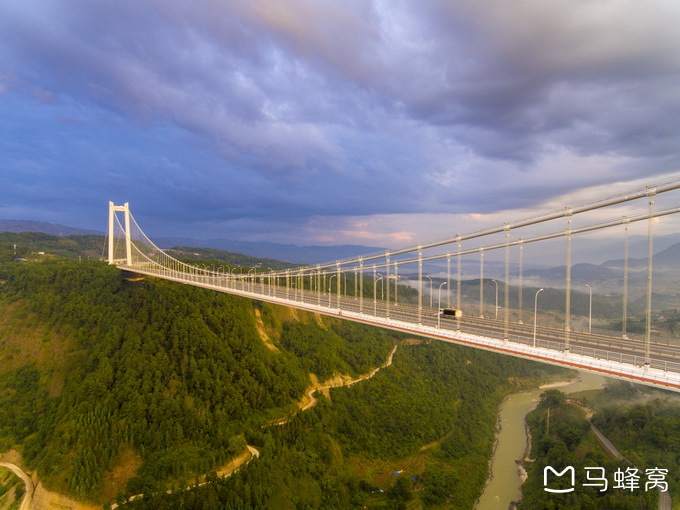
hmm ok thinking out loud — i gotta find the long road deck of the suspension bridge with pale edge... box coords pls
[118,264,680,392]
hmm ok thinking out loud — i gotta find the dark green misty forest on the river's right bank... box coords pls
[520,381,680,510]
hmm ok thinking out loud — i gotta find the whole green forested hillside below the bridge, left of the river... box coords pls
[0,260,554,508]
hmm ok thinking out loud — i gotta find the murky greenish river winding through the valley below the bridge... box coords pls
[475,372,606,510]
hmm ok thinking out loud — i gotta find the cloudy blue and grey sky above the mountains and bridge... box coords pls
[0,0,680,246]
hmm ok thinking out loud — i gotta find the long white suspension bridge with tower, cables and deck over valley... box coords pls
[108,181,680,391]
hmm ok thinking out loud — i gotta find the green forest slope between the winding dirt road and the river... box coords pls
[118,342,564,509]
